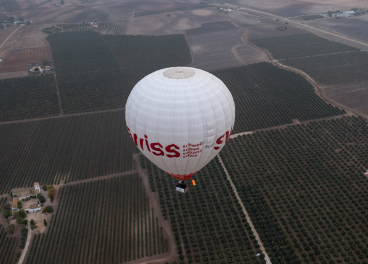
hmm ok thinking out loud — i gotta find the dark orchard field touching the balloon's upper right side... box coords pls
[212,62,345,134]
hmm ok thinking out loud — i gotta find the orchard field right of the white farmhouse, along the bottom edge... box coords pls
[24,174,168,264]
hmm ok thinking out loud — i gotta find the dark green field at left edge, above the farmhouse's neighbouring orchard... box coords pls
[0,75,59,122]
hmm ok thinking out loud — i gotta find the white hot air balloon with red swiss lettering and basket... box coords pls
[125,67,235,192]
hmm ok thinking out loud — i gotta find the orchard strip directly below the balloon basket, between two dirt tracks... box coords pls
[141,157,265,263]
